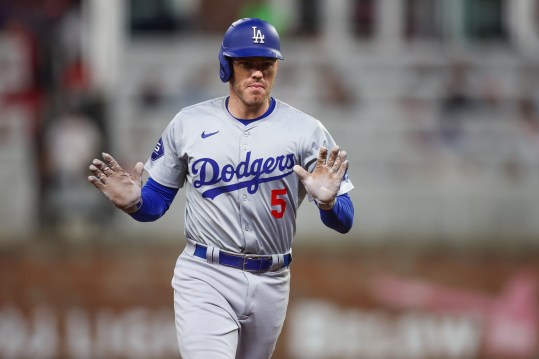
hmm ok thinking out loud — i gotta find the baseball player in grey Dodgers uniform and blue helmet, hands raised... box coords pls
[88,19,354,359]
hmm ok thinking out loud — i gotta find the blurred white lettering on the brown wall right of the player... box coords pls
[288,301,481,359]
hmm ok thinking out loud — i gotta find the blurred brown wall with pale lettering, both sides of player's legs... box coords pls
[0,248,539,359]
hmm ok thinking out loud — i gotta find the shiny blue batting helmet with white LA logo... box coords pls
[219,18,284,82]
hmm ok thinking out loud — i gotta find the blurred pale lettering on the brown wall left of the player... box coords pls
[0,305,178,359]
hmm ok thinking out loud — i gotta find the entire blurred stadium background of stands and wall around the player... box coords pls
[0,0,539,359]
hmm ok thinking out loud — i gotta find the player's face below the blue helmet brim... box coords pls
[230,57,278,108]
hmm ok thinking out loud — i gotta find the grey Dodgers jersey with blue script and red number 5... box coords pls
[145,97,354,255]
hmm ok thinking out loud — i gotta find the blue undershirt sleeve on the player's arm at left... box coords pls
[130,177,178,222]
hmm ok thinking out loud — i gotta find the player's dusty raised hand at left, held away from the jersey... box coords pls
[88,153,144,213]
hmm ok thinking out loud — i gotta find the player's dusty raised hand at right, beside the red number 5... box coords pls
[294,146,348,210]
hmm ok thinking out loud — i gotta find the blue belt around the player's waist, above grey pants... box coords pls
[194,244,292,273]
